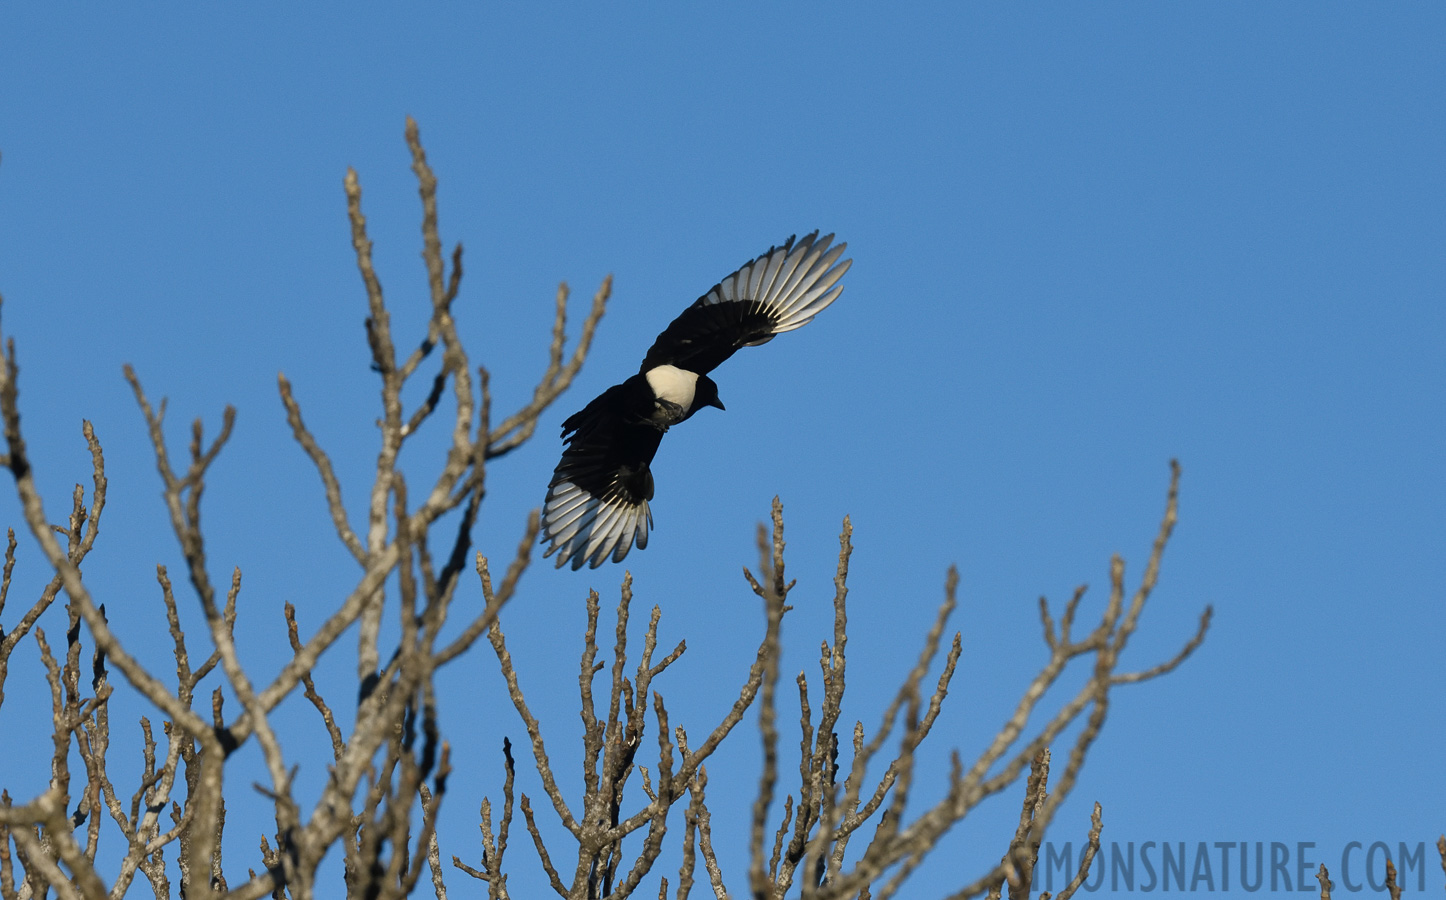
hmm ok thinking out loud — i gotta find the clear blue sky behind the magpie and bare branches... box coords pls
[0,3,1446,897]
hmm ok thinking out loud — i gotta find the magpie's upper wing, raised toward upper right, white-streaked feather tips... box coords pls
[639,232,853,375]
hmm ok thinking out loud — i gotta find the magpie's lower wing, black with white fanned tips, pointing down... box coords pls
[542,385,662,570]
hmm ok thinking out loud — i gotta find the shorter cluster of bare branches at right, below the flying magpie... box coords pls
[453,480,1210,900]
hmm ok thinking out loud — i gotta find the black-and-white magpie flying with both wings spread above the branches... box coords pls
[542,232,853,570]
